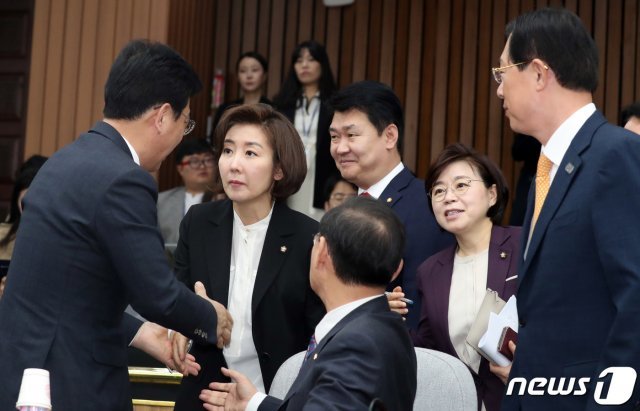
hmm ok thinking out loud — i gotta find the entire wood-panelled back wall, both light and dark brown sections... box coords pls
[25,0,640,222]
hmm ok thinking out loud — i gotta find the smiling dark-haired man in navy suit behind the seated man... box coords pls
[329,81,454,328]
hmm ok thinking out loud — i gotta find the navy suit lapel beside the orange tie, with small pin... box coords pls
[520,111,606,284]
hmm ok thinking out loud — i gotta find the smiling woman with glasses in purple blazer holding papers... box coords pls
[390,144,520,411]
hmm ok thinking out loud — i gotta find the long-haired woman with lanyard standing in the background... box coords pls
[274,40,338,220]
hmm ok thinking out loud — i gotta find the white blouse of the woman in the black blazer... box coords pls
[222,205,273,391]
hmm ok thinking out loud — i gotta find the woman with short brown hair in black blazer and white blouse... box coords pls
[173,104,324,411]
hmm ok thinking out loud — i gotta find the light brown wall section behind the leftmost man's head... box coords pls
[24,0,170,158]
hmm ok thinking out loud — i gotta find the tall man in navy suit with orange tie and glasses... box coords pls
[493,9,640,410]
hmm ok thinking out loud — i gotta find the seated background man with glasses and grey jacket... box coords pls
[158,139,216,244]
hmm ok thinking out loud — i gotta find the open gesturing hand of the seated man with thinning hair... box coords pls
[200,367,258,411]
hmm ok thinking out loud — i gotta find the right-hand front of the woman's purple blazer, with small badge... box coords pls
[487,225,518,295]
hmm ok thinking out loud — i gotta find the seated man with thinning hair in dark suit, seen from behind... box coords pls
[202,198,417,411]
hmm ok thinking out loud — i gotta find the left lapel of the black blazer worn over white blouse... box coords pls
[206,200,233,307]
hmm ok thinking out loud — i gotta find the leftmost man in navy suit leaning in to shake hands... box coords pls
[0,41,231,410]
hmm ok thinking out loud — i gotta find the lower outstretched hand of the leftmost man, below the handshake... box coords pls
[131,321,200,376]
